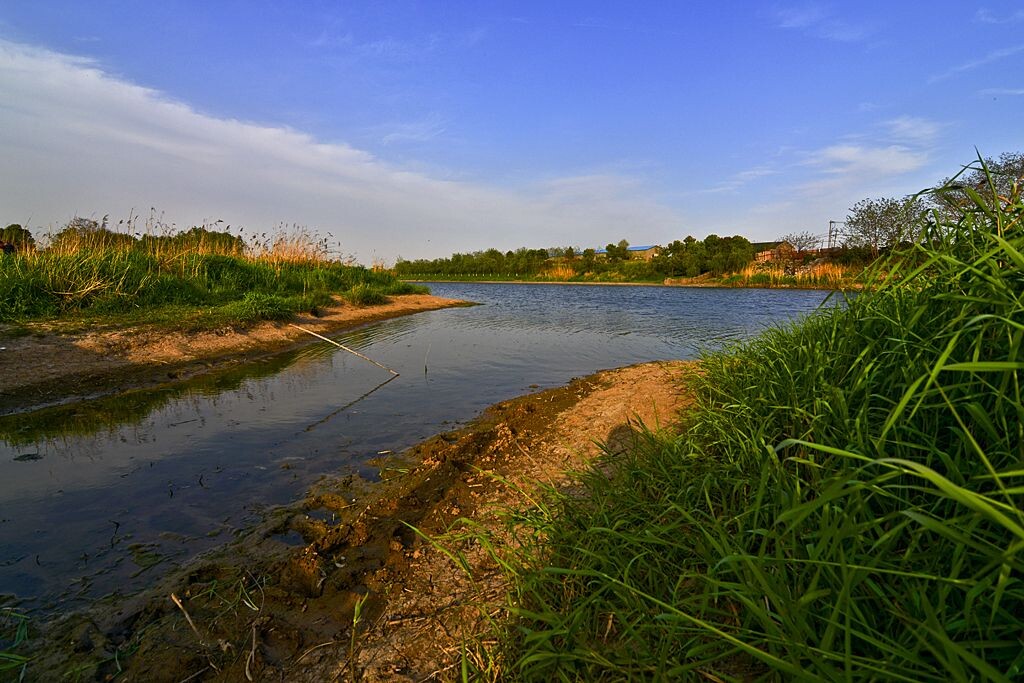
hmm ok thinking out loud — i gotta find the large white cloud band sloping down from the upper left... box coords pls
[0,41,681,263]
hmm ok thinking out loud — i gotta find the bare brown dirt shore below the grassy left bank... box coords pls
[0,294,465,415]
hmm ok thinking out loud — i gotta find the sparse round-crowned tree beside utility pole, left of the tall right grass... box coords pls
[844,197,927,256]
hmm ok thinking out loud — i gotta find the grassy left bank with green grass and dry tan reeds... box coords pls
[0,228,422,327]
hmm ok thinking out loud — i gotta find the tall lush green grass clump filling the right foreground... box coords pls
[491,157,1024,681]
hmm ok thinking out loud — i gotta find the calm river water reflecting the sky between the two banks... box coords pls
[0,284,825,608]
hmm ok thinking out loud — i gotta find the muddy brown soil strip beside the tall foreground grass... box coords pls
[29,362,692,681]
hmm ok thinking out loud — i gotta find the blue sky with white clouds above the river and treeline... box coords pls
[0,0,1024,265]
